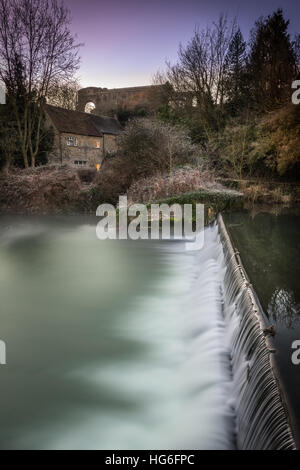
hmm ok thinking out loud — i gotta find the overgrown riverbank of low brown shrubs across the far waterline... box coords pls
[0,166,300,217]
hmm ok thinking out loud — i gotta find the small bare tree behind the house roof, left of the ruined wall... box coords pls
[47,79,80,110]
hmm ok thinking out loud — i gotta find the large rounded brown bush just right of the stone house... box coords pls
[91,119,202,204]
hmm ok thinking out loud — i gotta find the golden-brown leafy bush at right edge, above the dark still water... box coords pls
[203,105,300,178]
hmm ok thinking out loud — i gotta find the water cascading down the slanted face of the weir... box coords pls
[218,215,296,450]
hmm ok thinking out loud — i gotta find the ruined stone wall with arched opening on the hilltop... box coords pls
[77,85,157,114]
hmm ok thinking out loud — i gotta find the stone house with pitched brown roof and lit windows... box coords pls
[45,105,123,169]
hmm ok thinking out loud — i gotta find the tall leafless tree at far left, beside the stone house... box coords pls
[0,0,79,167]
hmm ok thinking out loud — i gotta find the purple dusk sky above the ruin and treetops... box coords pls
[64,0,300,88]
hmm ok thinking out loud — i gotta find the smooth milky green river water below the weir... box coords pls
[0,216,234,449]
